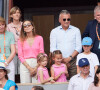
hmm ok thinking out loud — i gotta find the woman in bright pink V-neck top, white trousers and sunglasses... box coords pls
[18,20,44,83]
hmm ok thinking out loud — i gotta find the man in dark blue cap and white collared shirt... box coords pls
[68,58,94,90]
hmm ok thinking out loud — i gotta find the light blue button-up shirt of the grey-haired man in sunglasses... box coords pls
[50,25,82,58]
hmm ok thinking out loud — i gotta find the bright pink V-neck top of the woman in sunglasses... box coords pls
[18,35,44,63]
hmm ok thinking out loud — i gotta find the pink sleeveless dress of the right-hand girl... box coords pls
[52,63,67,82]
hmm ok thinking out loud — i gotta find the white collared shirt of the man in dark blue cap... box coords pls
[68,74,93,90]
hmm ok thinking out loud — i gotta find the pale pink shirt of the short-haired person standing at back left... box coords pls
[7,22,22,48]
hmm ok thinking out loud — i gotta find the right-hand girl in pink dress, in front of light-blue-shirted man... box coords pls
[51,50,68,82]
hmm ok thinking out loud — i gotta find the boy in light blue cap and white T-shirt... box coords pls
[76,37,99,76]
